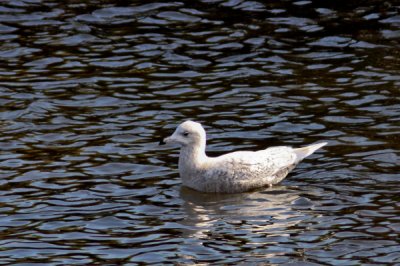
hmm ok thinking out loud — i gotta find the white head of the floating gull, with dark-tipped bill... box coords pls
[160,121,206,146]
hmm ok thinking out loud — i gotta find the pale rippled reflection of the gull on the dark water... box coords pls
[177,186,304,240]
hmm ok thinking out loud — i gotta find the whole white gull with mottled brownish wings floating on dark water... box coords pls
[160,121,327,193]
